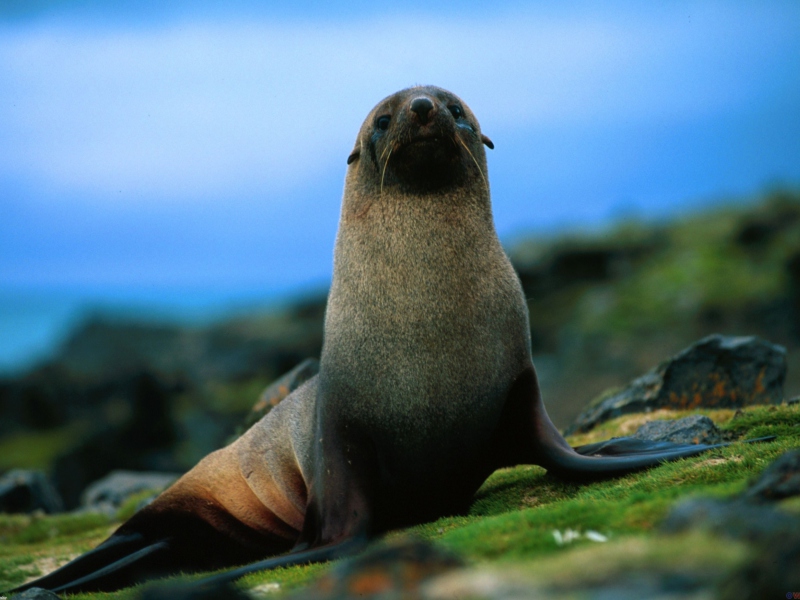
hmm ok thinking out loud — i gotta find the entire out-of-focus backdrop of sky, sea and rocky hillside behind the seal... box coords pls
[0,0,800,505]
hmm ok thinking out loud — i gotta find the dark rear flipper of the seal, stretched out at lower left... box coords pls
[11,533,169,593]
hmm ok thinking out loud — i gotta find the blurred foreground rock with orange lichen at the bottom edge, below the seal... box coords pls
[291,540,464,600]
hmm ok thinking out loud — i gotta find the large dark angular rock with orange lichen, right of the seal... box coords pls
[566,334,786,435]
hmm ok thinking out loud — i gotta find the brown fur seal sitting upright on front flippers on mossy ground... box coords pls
[12,86,768,592]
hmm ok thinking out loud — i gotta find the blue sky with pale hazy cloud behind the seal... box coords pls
[0,0,800,370]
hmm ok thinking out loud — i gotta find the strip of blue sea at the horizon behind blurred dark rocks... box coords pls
[0,285,324,375]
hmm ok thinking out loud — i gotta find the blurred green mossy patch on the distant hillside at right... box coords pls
[573,192,800,335]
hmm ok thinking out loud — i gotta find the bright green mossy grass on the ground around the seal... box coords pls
[0,405,800,599]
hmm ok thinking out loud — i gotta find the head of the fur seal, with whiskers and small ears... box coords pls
[347,86,494,195]
